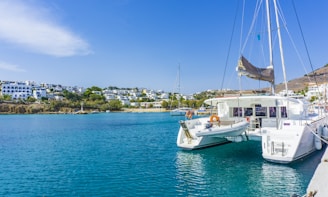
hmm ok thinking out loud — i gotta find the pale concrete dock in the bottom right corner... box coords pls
[306,148,328,197]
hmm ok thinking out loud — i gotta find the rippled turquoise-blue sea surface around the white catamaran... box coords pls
[0,113,323,196]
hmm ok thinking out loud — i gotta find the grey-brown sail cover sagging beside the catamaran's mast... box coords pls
[237,56,274,83]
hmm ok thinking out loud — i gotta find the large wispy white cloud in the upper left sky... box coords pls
[0,0,91,57]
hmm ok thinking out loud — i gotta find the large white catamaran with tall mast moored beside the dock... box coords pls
[177,0,328,164]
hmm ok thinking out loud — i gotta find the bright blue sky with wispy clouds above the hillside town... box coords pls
[0,0,328,93]
